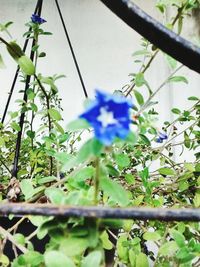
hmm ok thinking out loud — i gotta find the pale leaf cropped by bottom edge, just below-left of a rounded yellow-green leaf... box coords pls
[44,250,76,267]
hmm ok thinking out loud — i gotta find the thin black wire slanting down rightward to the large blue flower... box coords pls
[55,0,88,98]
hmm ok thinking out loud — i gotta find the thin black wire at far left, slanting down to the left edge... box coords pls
[1,1,41,123]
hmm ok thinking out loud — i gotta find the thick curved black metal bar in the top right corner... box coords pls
[100,0,200,73]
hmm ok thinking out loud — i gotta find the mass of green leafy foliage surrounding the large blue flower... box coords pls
[0,3,200,267]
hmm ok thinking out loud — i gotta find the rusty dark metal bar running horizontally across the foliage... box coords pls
[0,203,200,222]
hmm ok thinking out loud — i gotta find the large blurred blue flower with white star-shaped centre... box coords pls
[80,90,133,146]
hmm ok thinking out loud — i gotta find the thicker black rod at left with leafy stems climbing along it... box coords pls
[12,0,43,180]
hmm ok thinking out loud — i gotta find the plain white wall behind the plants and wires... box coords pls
[0,0,200,161]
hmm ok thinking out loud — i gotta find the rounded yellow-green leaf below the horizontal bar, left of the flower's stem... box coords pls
[60,237,89,257]
